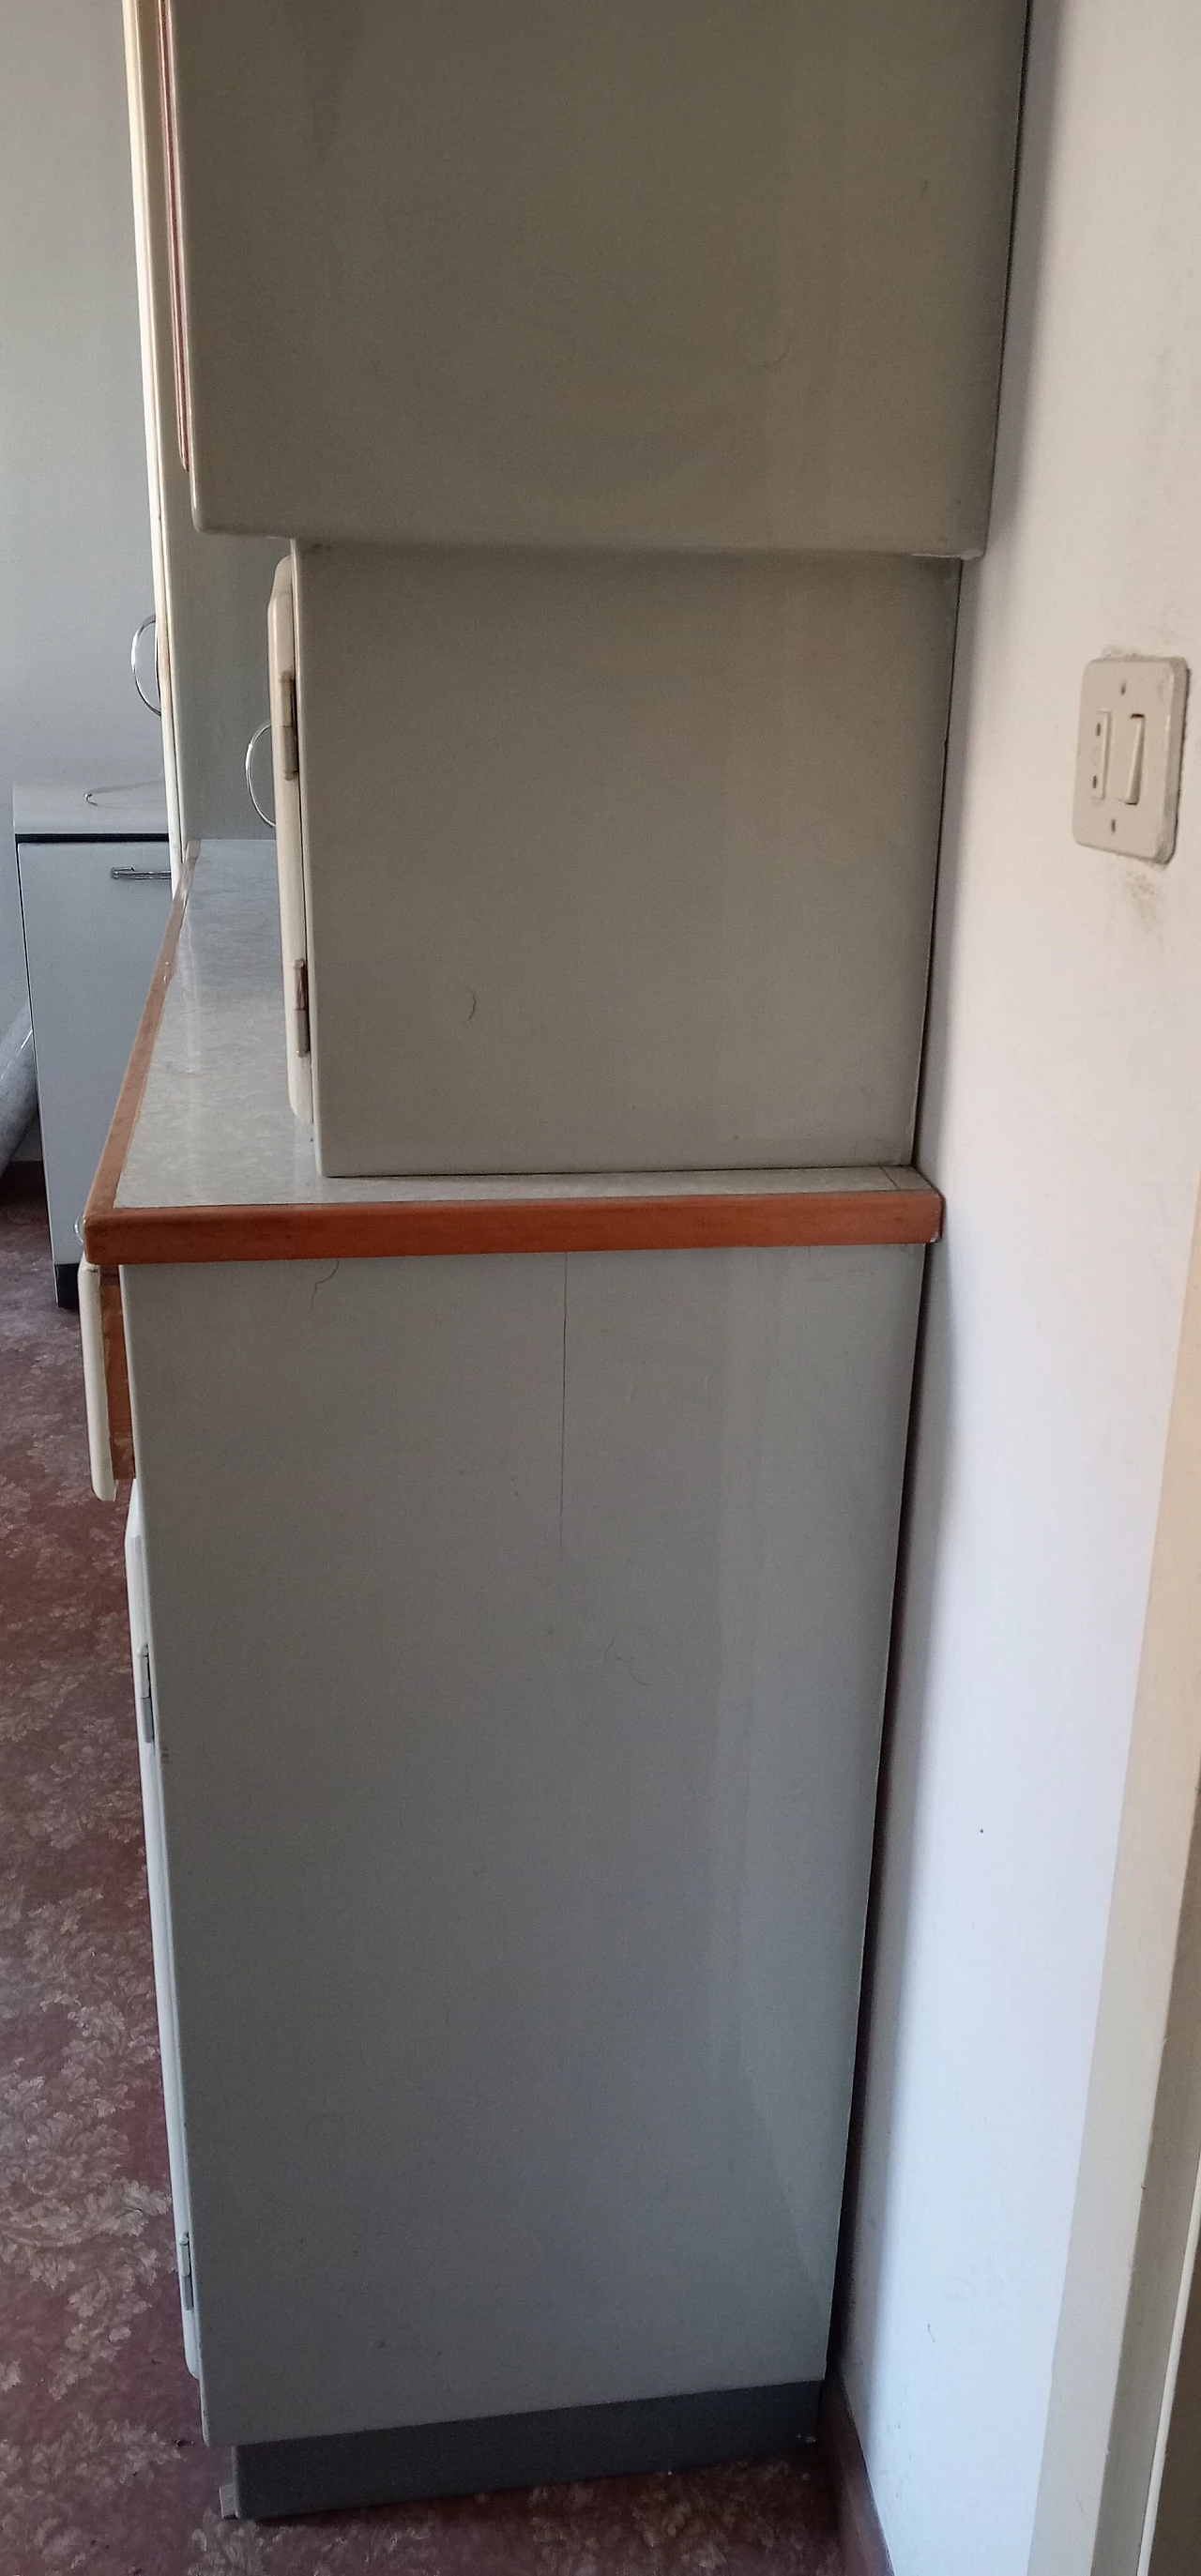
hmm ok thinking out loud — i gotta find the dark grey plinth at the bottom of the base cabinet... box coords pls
[235,2380,819,2522]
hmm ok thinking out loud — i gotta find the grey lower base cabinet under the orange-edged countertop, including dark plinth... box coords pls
[121,1244,922,2511]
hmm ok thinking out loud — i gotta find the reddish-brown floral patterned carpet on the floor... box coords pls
[0,1200,840,2576]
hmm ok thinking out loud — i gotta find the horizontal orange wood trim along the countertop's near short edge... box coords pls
[85,1180,943,1265]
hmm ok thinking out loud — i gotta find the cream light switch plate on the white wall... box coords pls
[1072,654,1188,865]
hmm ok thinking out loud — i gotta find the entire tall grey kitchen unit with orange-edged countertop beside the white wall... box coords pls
[85,0,1023,2514]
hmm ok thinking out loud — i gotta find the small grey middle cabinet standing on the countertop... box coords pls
[273,546,959,1175]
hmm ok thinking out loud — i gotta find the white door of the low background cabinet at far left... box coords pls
[18,840,170,1262]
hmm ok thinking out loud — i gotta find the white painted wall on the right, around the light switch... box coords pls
[845,0,1201,2576]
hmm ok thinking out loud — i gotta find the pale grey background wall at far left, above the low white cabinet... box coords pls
[0,0,162,1026]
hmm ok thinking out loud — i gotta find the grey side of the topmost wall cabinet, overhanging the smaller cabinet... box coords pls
[165,0,1026,554]
